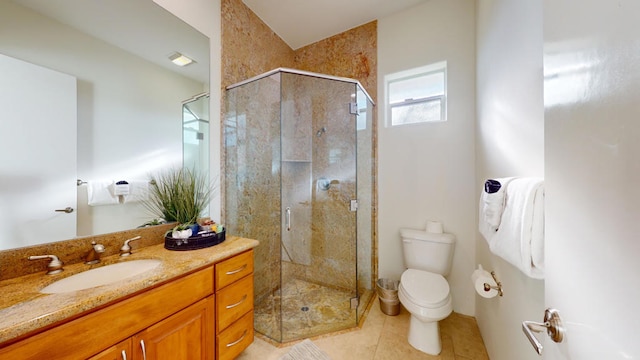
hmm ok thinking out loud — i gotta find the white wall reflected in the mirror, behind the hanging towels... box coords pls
[0,2,204,236]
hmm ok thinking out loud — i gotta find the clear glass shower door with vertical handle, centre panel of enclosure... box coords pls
[280,73,357,341]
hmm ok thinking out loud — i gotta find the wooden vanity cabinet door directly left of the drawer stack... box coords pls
[133,296,215,360]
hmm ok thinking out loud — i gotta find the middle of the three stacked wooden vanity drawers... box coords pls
[216,275,253,333]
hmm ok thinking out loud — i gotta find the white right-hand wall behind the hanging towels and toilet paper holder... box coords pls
[475,0,544,360]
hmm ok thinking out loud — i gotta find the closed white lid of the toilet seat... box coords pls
[400,269,449,308]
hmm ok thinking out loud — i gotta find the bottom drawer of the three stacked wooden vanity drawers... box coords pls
[216,311,253,360]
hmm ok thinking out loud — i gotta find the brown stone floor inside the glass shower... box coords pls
[254,279,373,342]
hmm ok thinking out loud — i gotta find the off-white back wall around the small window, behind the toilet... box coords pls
[377,0,476,315]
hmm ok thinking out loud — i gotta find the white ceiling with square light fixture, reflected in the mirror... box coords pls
[11,0,209,83]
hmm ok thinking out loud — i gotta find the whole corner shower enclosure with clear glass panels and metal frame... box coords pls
[224,69,374,342]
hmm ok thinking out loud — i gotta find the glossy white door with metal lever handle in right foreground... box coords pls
[538,0,640,360]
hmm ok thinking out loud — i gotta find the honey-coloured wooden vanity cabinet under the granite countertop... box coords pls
[0,250,253,360]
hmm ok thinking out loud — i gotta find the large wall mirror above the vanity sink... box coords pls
[0,0,209,250]
